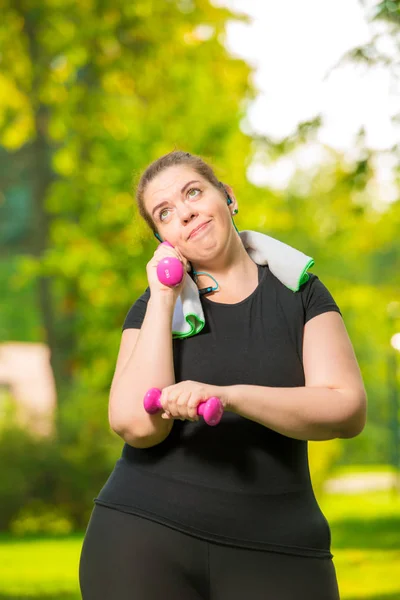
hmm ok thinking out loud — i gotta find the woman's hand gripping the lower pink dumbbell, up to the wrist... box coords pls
[160,380,226,421]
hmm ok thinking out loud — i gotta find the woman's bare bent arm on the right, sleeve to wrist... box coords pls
[223,311,367,440]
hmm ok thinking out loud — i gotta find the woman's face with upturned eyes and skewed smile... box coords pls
[144,165,236,260]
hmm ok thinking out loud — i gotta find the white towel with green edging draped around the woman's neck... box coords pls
[172,230,314,338]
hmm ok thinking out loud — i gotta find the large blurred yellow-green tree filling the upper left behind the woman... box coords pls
[0,0,253,408]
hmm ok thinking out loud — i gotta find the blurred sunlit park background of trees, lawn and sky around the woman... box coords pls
[0,0,400,600]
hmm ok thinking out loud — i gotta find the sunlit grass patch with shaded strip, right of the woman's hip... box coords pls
[319,491,400,600]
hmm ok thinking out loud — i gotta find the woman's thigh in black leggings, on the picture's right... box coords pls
[209,544,339,600]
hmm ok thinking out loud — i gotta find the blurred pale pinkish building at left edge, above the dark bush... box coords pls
[0,342,57,435]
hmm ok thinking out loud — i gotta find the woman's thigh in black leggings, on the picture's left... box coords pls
[79,505,208,600]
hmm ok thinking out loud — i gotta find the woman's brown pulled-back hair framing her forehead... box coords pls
[136,150,225,233]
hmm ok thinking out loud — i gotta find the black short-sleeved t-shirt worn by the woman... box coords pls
[95,265,340,558]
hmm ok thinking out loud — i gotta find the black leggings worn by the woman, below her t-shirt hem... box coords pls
[79,505,339,600]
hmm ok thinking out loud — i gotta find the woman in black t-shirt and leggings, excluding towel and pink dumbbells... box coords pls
[80,152,366,600]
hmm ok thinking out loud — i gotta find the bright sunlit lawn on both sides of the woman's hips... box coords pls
[0,491,400,600]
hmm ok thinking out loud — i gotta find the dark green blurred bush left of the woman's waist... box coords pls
[0,390,122,535]
